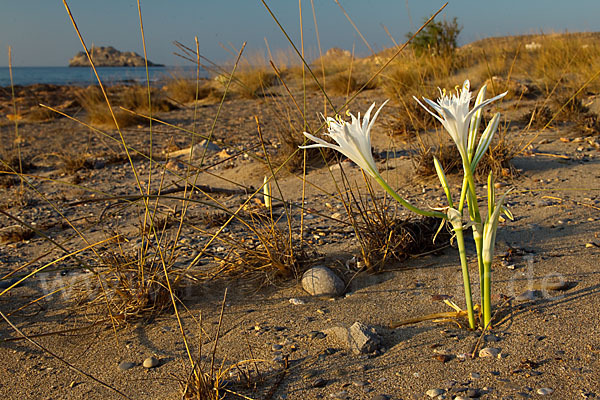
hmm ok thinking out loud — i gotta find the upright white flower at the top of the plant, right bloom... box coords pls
[414,80,506,160]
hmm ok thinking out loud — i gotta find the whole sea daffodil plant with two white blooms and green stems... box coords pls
[300,80,506,329]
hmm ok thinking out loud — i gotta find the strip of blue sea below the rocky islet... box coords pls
[0,66,208,87]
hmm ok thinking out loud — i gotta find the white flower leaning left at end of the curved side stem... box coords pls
[300,100,387,178]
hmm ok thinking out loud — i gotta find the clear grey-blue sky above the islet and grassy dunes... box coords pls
[0,0,600,66]
